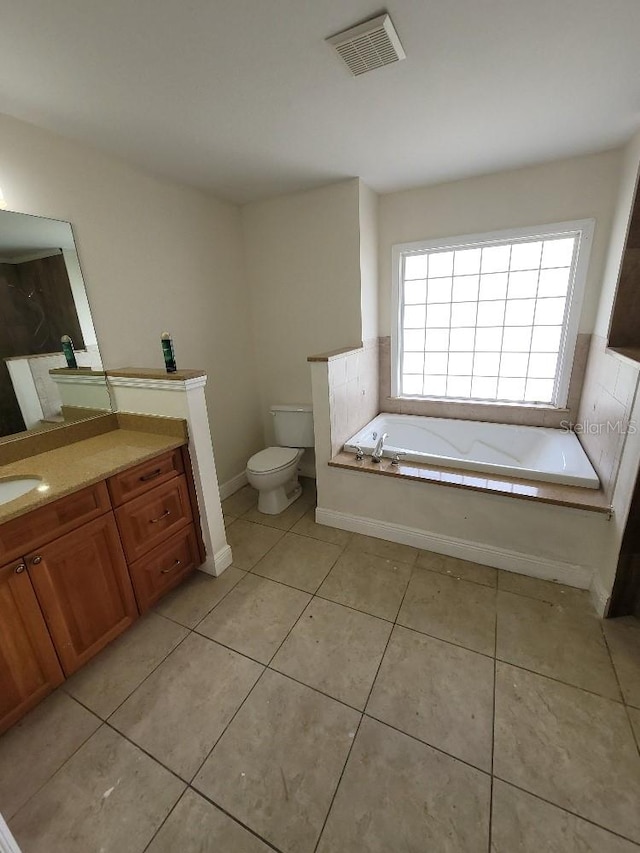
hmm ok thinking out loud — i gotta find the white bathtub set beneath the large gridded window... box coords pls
[344,414,600,489]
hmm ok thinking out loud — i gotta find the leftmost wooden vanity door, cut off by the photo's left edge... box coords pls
[0,562,64,733]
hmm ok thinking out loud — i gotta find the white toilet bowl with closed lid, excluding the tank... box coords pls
[247,447,304,515]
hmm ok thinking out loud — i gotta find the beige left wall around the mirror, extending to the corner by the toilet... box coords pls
[0,116,261,482]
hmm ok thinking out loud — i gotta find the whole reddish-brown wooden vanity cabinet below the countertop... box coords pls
[0,448,205,733]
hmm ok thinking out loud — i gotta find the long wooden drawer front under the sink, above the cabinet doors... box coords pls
[0,483,111,563]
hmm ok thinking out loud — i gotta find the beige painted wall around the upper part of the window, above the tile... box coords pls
[379,151,621,336]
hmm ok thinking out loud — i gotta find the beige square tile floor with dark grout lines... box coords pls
[0,486,640,853]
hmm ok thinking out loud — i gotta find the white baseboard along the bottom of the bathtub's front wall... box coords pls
[316,507,592,589]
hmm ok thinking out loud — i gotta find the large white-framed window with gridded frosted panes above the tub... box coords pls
[394,221,593,405]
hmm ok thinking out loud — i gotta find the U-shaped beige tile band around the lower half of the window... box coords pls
[379,333,592,428]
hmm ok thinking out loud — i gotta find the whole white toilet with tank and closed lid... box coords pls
[247,406,314,515]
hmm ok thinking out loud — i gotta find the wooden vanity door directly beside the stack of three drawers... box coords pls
[27,513,138,675]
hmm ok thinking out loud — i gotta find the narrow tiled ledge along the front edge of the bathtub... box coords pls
[329,451,611,513]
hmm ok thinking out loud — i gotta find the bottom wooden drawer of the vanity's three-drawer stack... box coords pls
[129,524,200,613]
